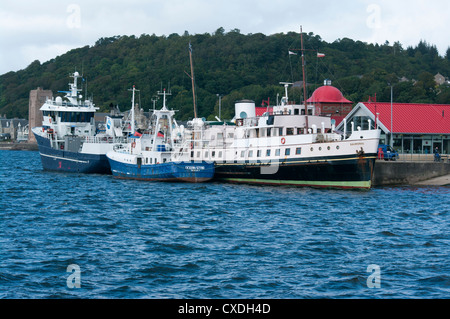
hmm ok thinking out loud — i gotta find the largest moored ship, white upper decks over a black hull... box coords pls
[183,28,380,189]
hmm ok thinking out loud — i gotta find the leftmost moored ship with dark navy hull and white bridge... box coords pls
[32,72,126,174]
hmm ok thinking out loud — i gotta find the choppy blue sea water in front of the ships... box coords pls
[0,151,450,299]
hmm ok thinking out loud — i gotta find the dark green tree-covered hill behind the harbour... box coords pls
[0,28,450,120]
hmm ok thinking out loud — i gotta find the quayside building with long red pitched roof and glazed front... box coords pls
[337,102,450,154]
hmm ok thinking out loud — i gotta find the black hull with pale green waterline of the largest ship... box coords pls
[214,154,376,189]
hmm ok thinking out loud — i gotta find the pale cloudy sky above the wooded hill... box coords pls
[0,0,450,74]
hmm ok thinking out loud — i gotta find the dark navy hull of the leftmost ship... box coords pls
[35,134,111,174]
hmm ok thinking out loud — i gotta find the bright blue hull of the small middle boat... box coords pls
[108,158,214,183]
